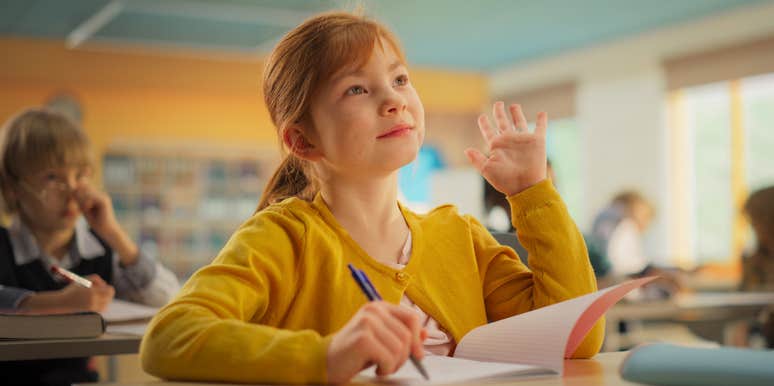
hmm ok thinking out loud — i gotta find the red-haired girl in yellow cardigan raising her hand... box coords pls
[140,13,602,383]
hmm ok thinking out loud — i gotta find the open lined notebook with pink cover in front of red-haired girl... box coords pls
[357,277,655,384]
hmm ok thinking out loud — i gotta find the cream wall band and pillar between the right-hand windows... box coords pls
[489,2,774,261]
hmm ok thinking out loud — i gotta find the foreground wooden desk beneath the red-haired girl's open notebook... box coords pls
[82,352,638,386]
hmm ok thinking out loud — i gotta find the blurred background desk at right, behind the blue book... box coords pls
[605,292,774,351]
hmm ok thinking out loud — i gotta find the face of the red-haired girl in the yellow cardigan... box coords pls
[307,41,425,177]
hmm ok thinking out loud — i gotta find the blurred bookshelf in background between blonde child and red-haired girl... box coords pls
[103,147,277,278]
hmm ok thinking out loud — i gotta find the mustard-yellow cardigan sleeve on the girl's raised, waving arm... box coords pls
[473,180,604,358]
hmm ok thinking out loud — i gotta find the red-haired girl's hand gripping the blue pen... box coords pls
[327,301,427,383]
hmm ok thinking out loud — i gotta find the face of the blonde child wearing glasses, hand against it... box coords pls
[15,166,91,231]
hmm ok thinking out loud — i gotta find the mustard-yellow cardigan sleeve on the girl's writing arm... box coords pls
[140,210,330,383]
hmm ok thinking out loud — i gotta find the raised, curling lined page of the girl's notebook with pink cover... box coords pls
[454,278,653,375]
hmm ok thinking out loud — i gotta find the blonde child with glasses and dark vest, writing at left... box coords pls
[0,109,179,385]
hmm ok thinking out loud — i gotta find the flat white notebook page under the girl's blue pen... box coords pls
[353,355,550,385]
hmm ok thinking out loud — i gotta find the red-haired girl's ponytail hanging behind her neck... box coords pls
[255,154,319,212]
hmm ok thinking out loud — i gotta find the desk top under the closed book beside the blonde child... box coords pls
[0,326,142,361]
